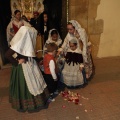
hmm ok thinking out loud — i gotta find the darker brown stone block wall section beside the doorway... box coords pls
[69,0,103,58]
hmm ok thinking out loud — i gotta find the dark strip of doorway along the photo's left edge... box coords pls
[0,0,11,64]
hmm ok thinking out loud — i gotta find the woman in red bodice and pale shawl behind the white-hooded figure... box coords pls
[7,10,31,46]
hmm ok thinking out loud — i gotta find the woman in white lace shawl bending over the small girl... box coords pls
[58,20,93,78]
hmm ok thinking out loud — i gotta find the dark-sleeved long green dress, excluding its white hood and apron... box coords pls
[6,49,49,111]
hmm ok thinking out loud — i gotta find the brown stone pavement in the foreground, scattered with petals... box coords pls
[0,57,120,120]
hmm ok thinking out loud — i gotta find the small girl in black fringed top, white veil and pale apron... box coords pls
[62,38,87,87]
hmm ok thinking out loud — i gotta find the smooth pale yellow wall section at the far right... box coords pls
[96,0,120,58]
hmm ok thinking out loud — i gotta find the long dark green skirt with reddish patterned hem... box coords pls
[9,65,49,111]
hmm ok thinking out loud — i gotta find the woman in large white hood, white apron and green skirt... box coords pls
[5,26,49,112]
